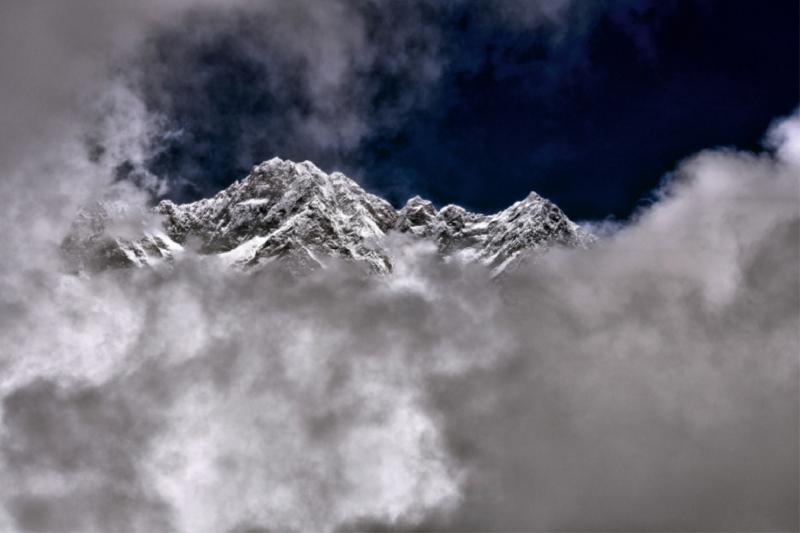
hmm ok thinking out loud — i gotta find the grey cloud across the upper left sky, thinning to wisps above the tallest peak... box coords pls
[0,0,593,206]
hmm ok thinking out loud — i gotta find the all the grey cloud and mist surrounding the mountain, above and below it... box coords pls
[0,1,800,531]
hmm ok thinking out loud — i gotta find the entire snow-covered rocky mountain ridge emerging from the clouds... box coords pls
[63,158,595,276]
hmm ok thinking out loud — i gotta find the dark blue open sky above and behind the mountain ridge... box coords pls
[134,0,800,219]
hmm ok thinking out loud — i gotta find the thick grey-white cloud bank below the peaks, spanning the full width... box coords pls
[0,115,800,531]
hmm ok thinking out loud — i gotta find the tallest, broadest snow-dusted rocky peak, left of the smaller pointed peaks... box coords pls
[156,159,397,272]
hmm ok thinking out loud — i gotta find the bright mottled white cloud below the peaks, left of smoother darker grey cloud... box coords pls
[2,243,507,531]
